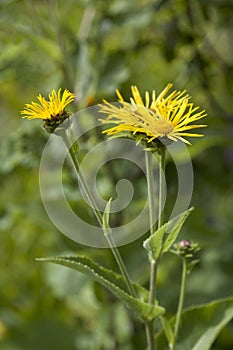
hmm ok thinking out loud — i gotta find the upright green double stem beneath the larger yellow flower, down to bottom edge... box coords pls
[145,148,166,350]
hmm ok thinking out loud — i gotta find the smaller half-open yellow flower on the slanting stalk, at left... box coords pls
[20,89,75,121]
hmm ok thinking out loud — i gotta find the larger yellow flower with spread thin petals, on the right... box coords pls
[100,84,207,144]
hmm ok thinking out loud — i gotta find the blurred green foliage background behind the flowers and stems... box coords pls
[0,0,233,350]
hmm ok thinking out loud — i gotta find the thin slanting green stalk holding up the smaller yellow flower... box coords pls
[60,131,137,298]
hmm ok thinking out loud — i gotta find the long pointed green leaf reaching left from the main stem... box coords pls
[37,256,165,320]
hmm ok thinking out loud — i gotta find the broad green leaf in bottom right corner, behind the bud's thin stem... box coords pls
[157,296,233,350]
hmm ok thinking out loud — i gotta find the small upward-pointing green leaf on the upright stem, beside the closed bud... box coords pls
[143,207,194,260]
